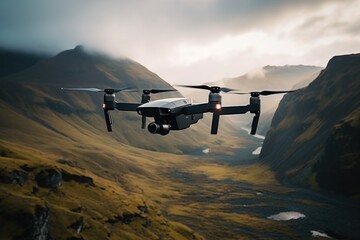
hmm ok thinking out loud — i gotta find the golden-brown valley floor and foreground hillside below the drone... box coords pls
[0,126,360,239]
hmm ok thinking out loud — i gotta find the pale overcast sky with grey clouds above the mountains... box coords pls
[0,0,360,83]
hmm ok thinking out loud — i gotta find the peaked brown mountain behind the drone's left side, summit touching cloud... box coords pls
[0,46,231,153]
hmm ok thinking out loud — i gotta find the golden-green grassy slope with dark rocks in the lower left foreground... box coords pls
[0,141,204,239]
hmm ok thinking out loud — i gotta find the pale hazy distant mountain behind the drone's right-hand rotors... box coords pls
[181,65,322,135]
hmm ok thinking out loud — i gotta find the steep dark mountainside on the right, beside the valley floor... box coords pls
[261,54,360,195]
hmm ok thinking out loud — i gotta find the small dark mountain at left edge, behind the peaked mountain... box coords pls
[0,48,49,78]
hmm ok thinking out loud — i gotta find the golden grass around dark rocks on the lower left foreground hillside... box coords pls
[0,141,208,239]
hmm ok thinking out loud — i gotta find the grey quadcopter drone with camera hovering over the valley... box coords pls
[61,85,297,136]
